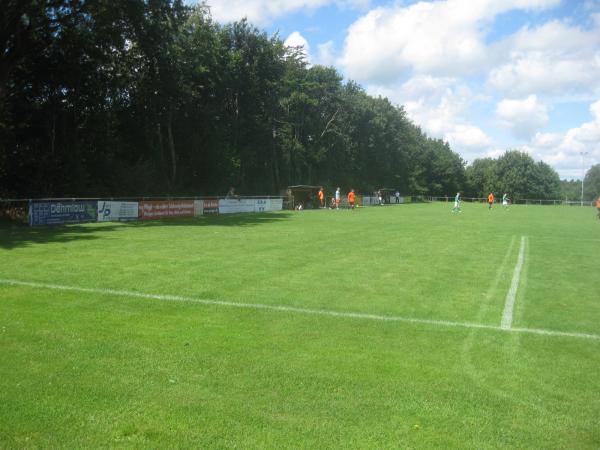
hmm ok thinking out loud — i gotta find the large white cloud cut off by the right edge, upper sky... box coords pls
[488,21,600,96]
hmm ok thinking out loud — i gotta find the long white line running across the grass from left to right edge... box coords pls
[0,279,600,340]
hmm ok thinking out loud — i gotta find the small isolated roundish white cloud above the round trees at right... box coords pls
[496,95,548,139]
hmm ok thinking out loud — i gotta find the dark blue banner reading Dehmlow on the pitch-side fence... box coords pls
[29,200,98,226]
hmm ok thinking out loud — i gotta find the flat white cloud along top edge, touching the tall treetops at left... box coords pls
[208,0,370,25]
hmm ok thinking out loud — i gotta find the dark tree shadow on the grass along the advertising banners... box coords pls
[0,211,293,250]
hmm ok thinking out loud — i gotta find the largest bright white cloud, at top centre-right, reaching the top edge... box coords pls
[338,0,558,82]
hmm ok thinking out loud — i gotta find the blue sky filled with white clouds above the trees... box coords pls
[199,0,600,179]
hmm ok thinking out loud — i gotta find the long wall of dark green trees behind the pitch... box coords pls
[0,0,596,198]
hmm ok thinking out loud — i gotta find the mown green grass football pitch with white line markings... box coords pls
[0,203,600,449]
